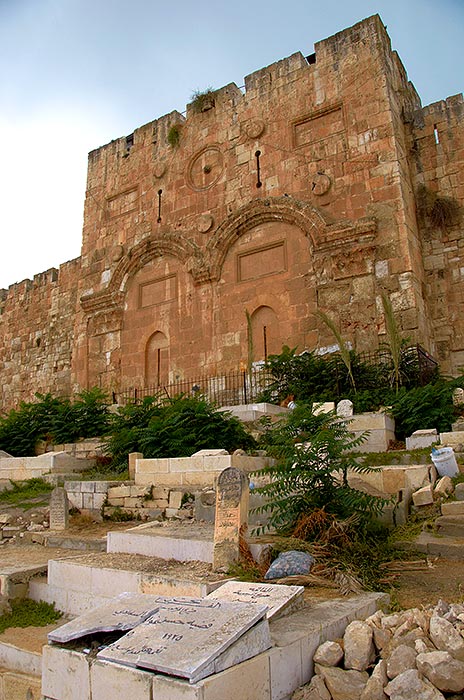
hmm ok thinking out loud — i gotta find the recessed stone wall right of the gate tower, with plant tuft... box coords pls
[411,94,464,373]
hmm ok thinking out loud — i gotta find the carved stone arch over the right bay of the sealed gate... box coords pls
[206,197,327,279]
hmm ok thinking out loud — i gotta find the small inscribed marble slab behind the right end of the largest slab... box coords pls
[207,581,304,620]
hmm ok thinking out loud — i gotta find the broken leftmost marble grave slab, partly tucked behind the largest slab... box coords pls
[48,593,158,644]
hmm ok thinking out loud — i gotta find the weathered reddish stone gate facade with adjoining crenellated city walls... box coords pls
[0,16,464,406]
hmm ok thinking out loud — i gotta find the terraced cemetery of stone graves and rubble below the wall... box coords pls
[0,386,464,700]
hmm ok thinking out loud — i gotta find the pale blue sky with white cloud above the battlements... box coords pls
[0,0,464,288]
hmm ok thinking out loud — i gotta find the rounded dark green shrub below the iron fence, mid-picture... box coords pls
[106,395,255,468]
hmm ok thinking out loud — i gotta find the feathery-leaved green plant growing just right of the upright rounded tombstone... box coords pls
[250,404,387,534]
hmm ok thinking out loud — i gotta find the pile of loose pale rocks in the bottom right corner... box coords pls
[292,600,464,700]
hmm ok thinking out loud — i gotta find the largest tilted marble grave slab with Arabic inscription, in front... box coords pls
[97,596,267,683]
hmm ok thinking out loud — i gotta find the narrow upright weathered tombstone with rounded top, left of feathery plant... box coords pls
[213,467,249,571]
